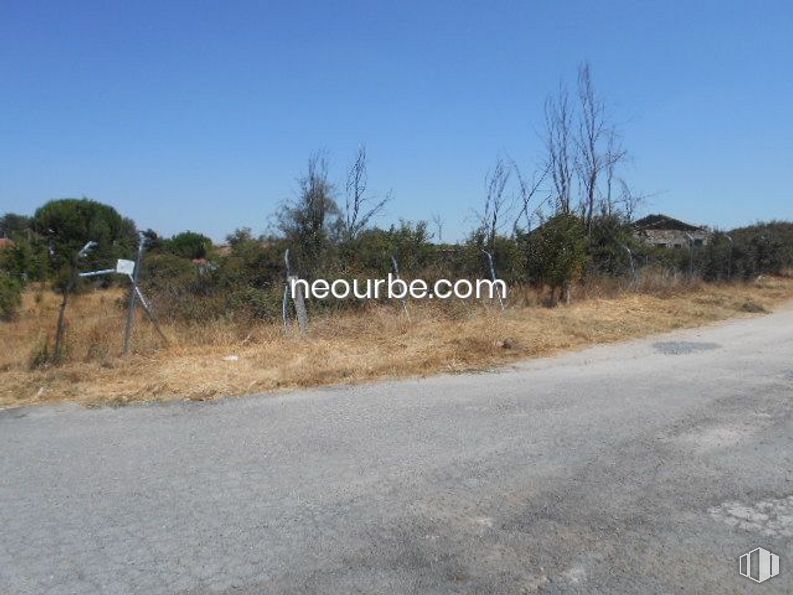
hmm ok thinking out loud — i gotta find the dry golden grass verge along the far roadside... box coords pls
[0,278,793,407]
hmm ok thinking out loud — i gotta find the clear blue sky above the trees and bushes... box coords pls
[0,0,793,239]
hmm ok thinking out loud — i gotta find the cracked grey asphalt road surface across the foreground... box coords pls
[0,311,793,594]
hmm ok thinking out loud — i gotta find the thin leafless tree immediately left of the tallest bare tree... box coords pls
[545,84,575,213]
